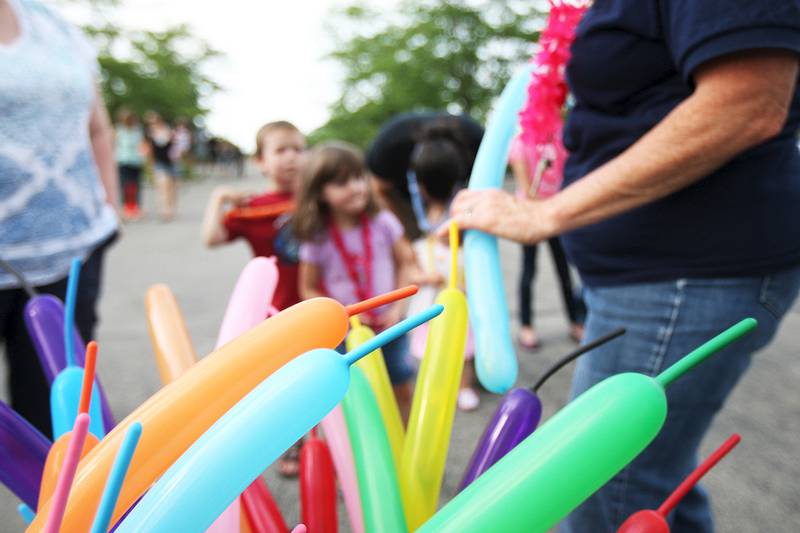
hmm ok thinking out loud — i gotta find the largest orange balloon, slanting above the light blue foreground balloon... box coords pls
[27,298,348,533]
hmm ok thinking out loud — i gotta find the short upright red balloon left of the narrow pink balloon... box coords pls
[300,431,338,533]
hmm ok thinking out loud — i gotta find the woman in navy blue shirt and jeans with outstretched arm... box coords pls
[452,0,800,533]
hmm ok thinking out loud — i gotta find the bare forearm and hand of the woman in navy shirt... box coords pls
[452,51,798,243]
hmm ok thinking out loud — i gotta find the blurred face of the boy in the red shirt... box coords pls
[257,129,306,191]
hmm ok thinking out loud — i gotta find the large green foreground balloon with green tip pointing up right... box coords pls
[419,318,756,533]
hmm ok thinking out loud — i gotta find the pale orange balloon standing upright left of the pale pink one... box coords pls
[144,284,197,384]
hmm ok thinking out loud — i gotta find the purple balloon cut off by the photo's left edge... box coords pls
[0,402,51,509]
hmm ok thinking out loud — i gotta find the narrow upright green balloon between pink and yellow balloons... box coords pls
[342,366,408,533]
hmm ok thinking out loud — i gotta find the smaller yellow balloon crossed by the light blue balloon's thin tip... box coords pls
[346,316,405,469]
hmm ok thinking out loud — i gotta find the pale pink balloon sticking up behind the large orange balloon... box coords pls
[206,257,278,533]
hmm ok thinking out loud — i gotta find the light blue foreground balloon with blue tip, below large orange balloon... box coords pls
[117,305,444,533]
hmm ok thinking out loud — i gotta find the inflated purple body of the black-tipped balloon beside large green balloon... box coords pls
[458,389,542,492]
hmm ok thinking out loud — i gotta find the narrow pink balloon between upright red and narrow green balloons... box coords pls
[321,404,364,533]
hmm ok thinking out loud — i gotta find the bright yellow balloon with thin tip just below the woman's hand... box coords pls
[399,223,467,531]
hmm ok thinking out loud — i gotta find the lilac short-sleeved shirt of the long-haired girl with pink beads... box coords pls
[300,211,403,314]
